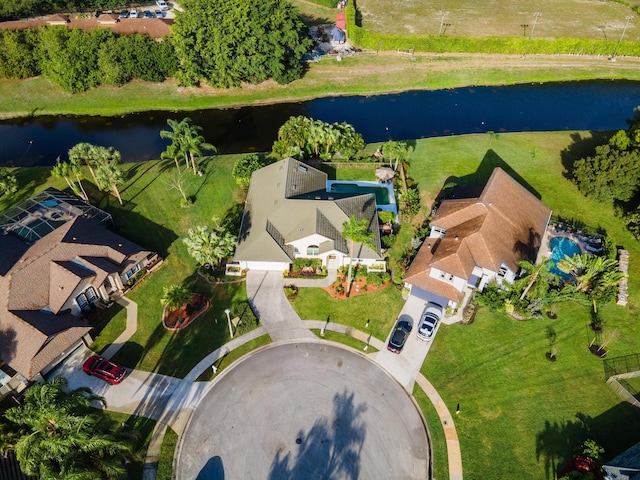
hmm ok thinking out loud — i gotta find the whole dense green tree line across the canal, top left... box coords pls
[0,0,312,93]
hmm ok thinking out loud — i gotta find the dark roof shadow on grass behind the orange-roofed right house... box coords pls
[436,149,542,206]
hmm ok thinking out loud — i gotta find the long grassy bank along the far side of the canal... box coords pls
[0,54,639,118]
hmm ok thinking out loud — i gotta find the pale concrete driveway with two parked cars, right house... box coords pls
[374,296,442,393]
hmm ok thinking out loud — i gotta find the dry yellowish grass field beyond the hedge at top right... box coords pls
[358,0,640,41]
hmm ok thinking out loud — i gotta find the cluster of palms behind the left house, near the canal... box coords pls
[51,143,126,205]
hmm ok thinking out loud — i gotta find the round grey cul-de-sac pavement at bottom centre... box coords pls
[174,341,430,480]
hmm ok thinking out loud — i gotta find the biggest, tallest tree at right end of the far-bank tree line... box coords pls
[172,0,312,88]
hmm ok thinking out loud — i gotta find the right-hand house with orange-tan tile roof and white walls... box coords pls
[404,168,551,308]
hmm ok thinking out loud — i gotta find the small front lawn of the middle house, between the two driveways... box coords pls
[291,286,404,341]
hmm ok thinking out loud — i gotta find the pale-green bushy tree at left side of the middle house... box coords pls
[182,226,238,268]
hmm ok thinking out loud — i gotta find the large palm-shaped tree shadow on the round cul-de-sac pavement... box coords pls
[268,390,367,480]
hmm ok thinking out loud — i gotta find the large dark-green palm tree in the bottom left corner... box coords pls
[5,378,131,480]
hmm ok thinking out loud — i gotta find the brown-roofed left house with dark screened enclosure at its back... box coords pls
[0,189,157,396]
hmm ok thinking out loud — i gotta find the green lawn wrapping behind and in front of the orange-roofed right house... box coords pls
[402,132,640,479]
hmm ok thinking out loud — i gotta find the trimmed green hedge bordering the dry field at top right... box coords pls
[346,5,640,57]
